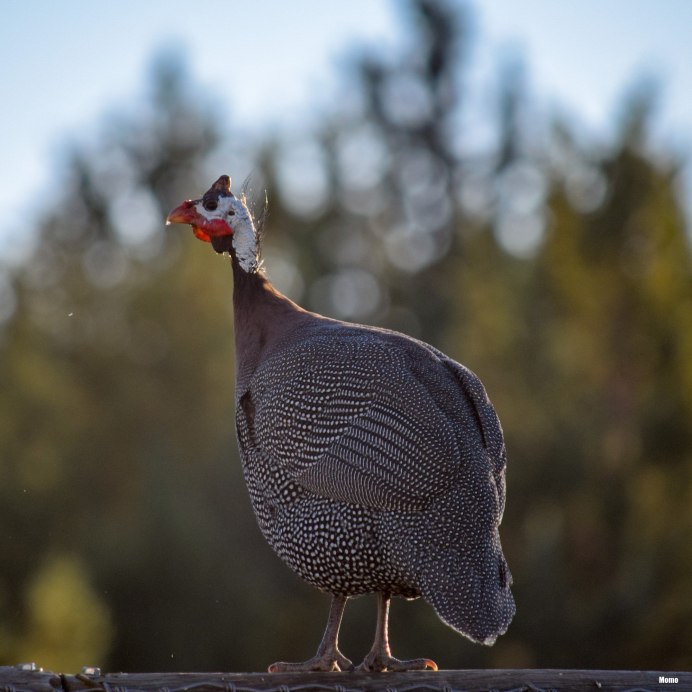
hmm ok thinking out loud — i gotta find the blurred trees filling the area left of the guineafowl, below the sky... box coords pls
[0,52,260,667]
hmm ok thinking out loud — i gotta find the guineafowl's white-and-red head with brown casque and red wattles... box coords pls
[166,175,259,271]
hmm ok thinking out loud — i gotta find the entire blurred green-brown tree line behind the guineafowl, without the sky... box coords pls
[0,0,692,671]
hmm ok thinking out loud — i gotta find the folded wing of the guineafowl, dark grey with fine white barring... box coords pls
[246,333,500,510]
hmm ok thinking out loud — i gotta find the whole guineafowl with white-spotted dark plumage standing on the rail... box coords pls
[166,175,515,673]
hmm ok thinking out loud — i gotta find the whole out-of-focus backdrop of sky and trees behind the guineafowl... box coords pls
[0,0,692,672]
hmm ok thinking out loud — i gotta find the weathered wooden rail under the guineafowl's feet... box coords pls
[0,664,692,692]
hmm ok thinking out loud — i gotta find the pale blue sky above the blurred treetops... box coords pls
[0,0,692,262]
